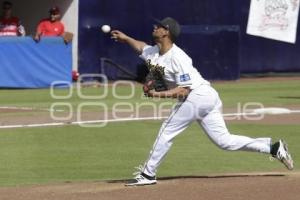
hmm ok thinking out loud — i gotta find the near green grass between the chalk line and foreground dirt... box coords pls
[0,121,300,185]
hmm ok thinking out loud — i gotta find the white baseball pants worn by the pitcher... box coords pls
[143,85,271,176]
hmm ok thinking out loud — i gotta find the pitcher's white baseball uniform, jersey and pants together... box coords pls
[140,44,271,176]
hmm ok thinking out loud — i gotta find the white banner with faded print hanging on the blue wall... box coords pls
[247,0,300,43]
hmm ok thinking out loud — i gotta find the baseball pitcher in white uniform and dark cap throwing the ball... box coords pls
[111,17,293,186]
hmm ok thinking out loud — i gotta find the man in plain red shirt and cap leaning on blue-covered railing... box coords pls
[34,6,65,41]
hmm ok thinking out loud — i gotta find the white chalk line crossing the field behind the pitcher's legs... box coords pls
[0,108,300,129]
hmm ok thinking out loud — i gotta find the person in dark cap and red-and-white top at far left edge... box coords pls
[0,1,25,36]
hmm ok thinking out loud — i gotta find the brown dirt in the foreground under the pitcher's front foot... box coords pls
[0,174,300,200]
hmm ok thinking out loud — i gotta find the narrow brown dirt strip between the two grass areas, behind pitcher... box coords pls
[0,105,300,128]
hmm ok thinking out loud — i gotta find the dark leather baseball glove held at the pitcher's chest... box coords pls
[143,60,168,96]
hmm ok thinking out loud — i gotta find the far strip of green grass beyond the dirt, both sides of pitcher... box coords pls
[0,80,300,112]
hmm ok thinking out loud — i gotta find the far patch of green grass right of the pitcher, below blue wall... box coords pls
[213,80,300,107]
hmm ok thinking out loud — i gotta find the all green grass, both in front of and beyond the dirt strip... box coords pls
[0,80,300,186]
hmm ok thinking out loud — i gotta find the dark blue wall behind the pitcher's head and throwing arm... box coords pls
[79,0,300,80]
